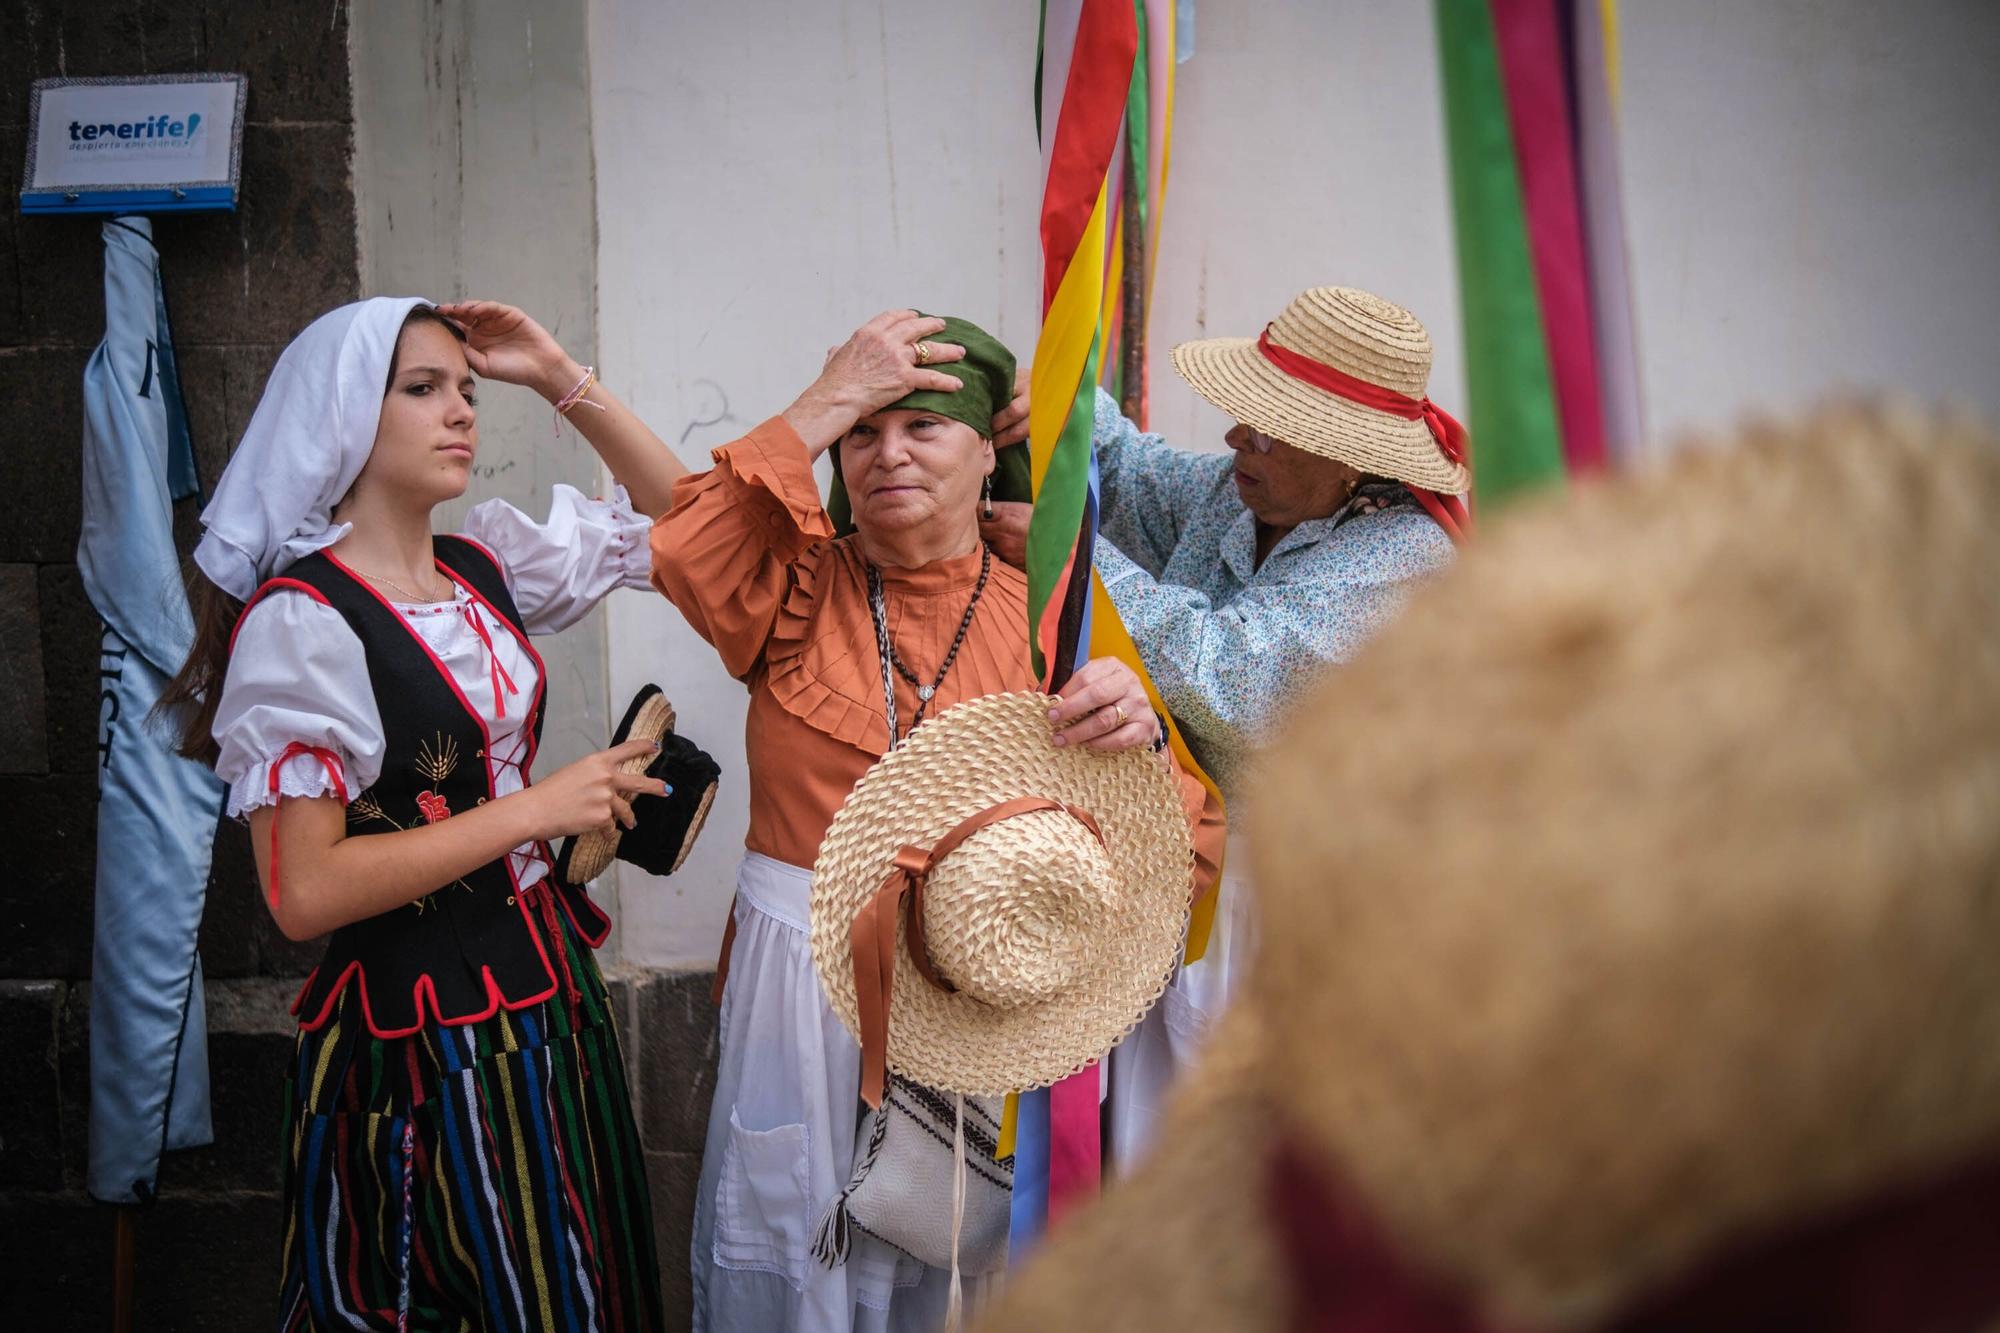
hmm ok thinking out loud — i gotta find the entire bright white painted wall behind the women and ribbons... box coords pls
[590,0,2000,965]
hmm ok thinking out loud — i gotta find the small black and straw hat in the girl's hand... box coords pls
[556,685,720,885]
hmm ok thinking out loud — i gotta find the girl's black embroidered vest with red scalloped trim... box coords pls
[244,536,610,1037]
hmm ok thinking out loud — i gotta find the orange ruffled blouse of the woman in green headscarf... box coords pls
[652,416,1222,876]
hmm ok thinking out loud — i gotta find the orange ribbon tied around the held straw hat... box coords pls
[848,797,1104,1109]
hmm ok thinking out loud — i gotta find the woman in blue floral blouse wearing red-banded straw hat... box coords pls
[980,286,1472,1159]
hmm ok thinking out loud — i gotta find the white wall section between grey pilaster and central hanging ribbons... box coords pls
[590,0,1040,965]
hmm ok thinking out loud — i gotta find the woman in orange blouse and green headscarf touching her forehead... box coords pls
[652,310,1214,1333]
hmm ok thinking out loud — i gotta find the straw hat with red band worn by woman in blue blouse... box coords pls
[1172,286,1472,494]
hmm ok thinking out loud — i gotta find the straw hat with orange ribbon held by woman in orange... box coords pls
[812,693,1194,1097]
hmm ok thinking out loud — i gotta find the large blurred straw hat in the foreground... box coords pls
[982,408,2000,1333]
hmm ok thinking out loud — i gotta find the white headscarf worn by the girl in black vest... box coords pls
[194,296,430,602]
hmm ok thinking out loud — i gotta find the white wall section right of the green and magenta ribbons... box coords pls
[1620,0,2000,438]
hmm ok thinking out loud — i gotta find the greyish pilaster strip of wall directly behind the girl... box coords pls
[348,0,616,913]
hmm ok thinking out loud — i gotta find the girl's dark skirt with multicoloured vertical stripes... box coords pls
[280,888,662,1333]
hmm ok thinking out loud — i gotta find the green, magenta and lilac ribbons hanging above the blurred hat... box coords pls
[1436,0,1640,500]
